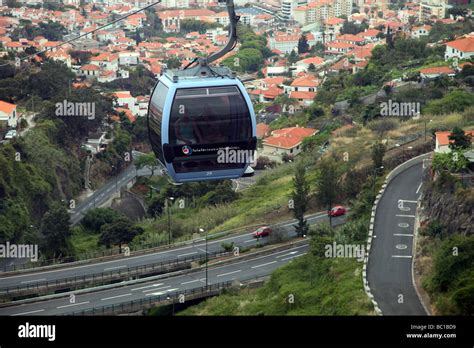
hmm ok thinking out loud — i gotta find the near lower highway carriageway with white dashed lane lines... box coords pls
[0,244,309,316]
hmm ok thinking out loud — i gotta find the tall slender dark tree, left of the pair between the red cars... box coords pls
[291,162,309,237]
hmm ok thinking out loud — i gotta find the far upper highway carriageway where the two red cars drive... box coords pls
[0,213,345,291]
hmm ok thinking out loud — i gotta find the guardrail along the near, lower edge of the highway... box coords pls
[65,281,235,316]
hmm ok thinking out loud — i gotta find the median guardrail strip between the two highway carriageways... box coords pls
[0,251,231,299]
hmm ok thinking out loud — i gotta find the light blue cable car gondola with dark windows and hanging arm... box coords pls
[148,0,257,183]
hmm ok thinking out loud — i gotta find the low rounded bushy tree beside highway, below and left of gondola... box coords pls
[99,216,144,250]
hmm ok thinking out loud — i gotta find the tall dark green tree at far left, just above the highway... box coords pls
[40,203,71,258]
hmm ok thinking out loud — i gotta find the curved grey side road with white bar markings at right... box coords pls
[367,164,426,315]
